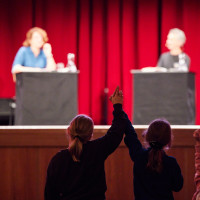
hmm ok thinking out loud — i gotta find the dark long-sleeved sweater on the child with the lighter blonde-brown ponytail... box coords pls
[45,104,128,200]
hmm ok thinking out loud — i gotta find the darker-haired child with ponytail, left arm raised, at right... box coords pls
[124,119,183,200]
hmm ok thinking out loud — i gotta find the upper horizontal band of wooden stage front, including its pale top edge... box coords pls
[0,125,200,147]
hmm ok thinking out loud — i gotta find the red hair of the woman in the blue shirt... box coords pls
[23,27,48,47]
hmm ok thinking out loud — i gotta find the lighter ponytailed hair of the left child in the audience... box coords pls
[68,115,94,162]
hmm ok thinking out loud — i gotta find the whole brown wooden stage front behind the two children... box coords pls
[0,126,200,200]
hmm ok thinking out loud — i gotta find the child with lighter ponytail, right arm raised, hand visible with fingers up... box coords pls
[45,87,128,200]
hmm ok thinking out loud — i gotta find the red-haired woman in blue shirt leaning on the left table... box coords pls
[12,27,56,81]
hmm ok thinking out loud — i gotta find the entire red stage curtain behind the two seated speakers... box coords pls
[0,0,200,124]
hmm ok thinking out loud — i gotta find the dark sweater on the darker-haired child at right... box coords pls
[124,119,183,200]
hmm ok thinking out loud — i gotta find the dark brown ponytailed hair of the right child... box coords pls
[144,119,172,173]
